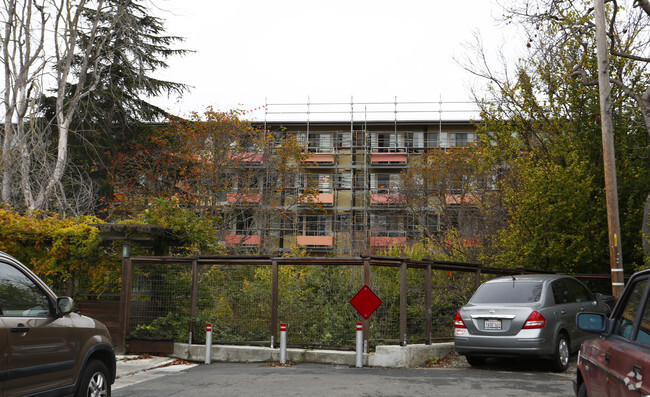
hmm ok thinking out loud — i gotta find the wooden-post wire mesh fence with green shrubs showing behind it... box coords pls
[120,254,605,348]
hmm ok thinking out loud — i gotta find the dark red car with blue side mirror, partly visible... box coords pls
[574,269,650,397]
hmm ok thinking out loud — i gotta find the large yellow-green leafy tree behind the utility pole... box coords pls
[460,1,650,272]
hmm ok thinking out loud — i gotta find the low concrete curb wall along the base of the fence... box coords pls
[171,342,454,368]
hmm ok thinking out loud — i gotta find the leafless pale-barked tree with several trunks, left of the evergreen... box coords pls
[0,0,138,211]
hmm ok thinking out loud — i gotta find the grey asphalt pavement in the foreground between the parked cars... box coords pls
[113,363,573,397]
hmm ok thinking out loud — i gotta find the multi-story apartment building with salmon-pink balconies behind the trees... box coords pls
[220,98,476,255]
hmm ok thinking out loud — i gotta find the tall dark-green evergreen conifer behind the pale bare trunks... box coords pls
[66,0,188,213]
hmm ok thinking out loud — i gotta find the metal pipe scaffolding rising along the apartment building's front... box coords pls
[225,98,478,255]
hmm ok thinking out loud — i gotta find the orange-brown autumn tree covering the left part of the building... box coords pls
[110,110,304,251]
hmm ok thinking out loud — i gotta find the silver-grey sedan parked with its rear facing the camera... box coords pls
[454,274,611,372]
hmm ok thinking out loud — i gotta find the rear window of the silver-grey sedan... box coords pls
[469,280,542,303]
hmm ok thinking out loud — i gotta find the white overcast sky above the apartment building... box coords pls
[148,0,516,119]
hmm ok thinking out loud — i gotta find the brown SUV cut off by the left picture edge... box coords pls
[0,252,115,396]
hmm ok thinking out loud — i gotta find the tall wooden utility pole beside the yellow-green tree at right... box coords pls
[594,0,624,300]
